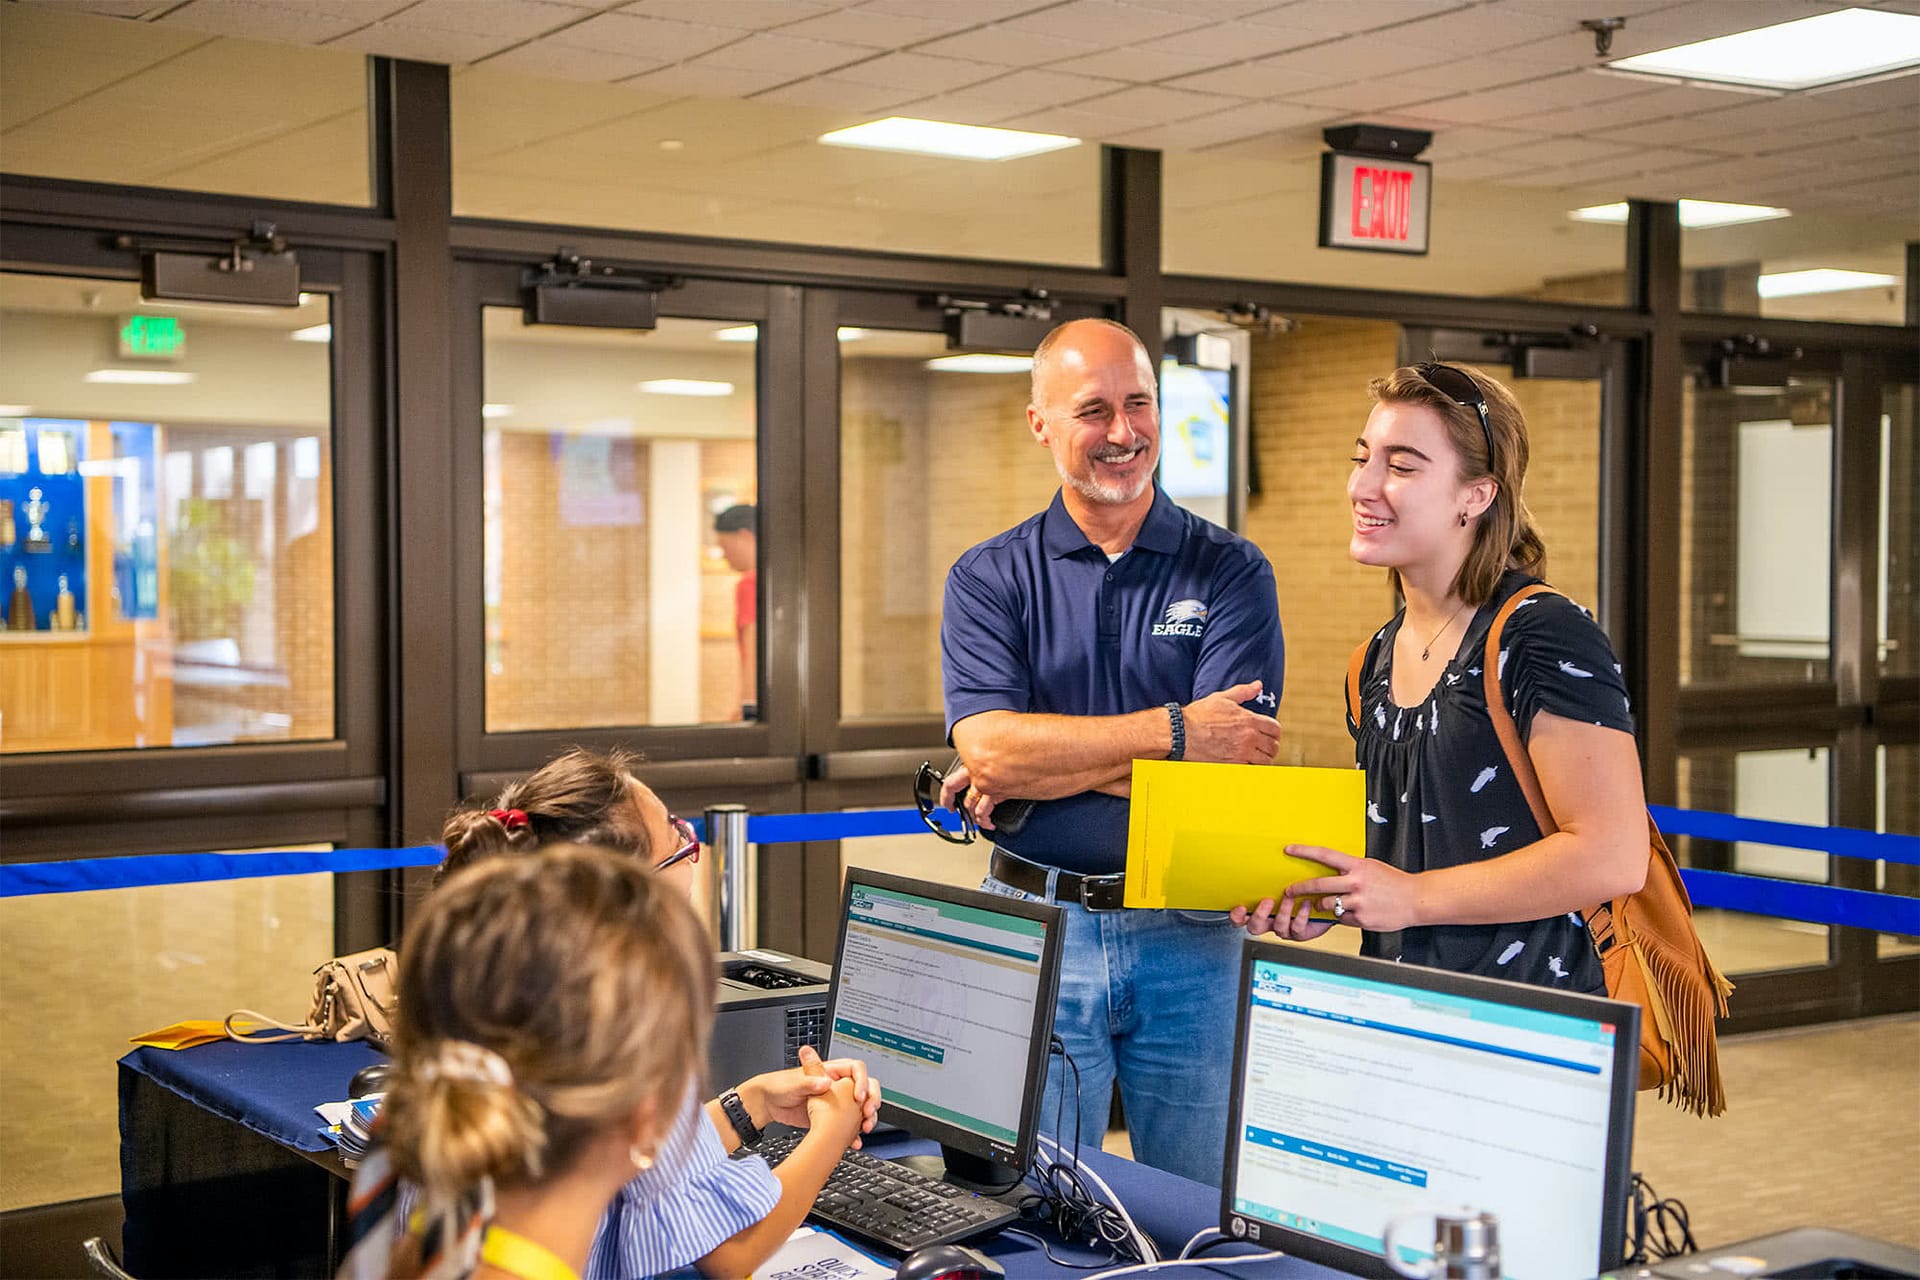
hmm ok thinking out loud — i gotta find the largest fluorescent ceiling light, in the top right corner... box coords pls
[1609,10,1920,90]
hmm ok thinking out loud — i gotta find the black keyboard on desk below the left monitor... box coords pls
[755,1128,1020,1255]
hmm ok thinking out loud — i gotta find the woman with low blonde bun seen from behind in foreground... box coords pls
[340,848,733,1280]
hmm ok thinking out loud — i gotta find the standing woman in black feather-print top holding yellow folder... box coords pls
[1235,365,1647,994]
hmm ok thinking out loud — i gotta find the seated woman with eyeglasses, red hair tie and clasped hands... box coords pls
[432,748,881,1278]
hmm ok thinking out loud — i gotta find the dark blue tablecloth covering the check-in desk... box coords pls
[119,1042,1338,1280]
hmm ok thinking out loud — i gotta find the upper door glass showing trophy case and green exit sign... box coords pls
[0,273,334,752]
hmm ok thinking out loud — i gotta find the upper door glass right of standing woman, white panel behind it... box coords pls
[1680,370,1834,685]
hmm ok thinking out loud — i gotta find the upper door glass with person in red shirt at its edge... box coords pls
[482,307,758,733]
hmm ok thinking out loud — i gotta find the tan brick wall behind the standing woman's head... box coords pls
[1246,317,1599,768]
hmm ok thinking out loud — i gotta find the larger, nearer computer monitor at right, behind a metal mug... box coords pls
[1219,942,1640,1280]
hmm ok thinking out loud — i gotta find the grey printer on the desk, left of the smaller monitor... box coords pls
[707,948,833,1092]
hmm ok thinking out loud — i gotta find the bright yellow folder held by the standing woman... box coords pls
[1125,760,1367,919]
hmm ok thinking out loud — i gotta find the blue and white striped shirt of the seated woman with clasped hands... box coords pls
[584,1090,780,1280]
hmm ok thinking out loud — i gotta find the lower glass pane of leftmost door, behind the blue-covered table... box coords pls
[0,844,334,1213]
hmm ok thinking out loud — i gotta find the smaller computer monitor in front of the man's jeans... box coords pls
[828,867,1062,1190]
